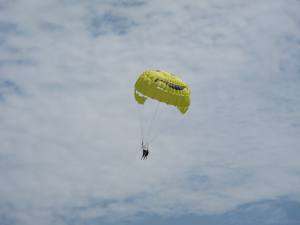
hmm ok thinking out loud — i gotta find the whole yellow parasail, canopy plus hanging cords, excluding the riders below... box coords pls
[134,70,191,148]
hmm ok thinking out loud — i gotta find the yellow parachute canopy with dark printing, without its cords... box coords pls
[134,70,191,114]
